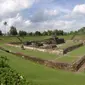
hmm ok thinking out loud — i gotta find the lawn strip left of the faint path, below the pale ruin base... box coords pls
[2,45,58,60]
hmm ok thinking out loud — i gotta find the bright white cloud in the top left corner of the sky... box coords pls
[0,0,35,15]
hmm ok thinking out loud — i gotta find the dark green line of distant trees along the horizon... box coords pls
[0,26,85,36]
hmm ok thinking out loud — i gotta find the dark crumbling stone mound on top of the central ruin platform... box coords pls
[24,37,65,49]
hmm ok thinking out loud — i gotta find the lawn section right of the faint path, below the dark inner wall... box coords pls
[57,46,85,62]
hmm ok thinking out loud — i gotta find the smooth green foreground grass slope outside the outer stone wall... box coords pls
[0,51,85,85]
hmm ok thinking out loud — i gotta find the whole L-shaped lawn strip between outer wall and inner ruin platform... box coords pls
[2,45,85,63]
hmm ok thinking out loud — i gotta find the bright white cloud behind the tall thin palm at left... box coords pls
[0,13,31,32]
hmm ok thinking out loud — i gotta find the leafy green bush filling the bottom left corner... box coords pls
[0,57,29,85]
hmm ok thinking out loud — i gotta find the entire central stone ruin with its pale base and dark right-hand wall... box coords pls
[8,36,83,55]
